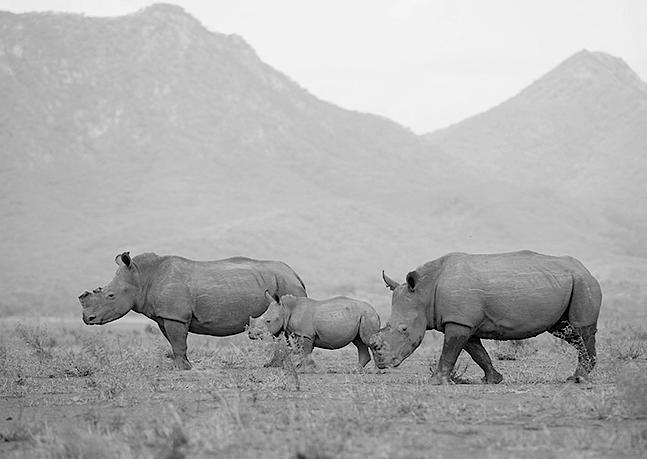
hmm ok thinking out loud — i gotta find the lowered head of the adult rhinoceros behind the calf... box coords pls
[369,271,427,368]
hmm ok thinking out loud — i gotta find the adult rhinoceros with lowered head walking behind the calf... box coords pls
[369,251,602,384]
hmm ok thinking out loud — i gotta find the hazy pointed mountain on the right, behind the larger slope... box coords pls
[426,50,647,246]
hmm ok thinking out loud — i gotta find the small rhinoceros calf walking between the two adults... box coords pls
[248,292,380,368]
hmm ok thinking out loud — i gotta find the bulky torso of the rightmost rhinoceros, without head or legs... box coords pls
[435,251,599,339]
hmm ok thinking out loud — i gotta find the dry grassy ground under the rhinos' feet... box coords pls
[0,319,647,458]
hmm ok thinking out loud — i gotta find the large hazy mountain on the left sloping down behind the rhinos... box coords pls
[0,4,640,315]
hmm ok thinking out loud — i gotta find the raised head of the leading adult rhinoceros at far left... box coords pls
[79,252,139,325]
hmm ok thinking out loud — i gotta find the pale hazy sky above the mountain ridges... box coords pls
[0,0,647,133]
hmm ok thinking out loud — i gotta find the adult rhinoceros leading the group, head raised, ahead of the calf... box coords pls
[79,252,306,369]
